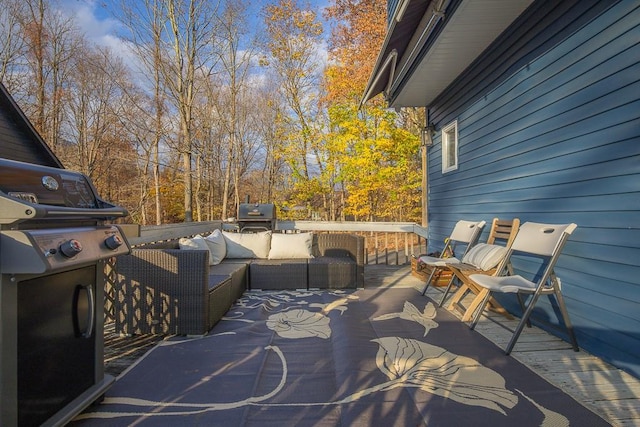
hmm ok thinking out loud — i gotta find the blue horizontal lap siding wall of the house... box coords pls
[428,1,640,377]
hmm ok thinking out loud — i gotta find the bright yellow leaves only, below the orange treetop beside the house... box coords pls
[329,106,420,221]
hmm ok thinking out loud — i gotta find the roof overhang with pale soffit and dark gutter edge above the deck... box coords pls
[362,0,533,108]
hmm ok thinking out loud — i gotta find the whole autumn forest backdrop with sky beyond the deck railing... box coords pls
[0,0,424,224]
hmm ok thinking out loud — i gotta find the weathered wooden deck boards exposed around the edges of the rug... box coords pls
[105,264,640,427]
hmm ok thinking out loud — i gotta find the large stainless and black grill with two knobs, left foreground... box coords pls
[0,159,130,427]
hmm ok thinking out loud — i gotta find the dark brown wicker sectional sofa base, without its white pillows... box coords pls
[114,233,365,335]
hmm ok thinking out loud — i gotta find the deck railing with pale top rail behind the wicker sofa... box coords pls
[123,221,427,265]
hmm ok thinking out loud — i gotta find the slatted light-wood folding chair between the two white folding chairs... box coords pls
[440,218,520,322]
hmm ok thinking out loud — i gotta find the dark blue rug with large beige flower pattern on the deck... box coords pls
[74,288,608,427]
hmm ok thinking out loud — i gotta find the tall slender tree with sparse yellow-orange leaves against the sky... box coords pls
[262,0,325,216]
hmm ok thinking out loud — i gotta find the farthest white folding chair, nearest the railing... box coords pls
[419,220,487,295]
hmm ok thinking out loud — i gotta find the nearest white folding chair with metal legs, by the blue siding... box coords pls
[469,222,578,354]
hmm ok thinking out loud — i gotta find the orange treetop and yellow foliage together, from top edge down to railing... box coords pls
[324,0,421,221]
